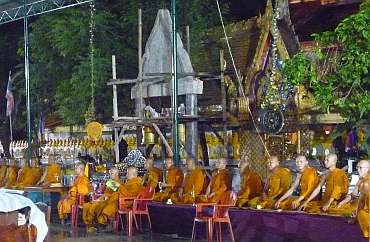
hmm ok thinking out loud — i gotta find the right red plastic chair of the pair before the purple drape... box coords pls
[212,191,237,242]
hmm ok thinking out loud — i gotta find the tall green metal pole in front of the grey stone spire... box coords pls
[171,0,179,166]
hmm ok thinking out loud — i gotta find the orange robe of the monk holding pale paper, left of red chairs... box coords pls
[82,180,122,225]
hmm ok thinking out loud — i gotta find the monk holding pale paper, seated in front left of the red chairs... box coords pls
[82,167,122,232]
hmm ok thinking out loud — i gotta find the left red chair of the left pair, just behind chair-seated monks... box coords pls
[113,197,136,237]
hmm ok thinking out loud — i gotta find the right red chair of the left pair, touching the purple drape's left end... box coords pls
[132,186,154,231]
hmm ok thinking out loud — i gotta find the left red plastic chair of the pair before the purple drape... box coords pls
[191,203,215,242]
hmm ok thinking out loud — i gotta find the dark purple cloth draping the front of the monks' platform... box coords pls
[149,203,367,242]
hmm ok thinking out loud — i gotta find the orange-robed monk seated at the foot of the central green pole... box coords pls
[153,158,184,202]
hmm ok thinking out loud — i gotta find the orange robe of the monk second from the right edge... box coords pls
[306,168,349,213]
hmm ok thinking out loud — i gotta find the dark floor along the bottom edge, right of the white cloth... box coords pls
[48,224,195,242]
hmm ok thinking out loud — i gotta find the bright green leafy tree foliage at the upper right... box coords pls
[283,0,370,121]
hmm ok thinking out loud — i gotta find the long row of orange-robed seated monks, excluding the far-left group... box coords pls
[58,154,370,237]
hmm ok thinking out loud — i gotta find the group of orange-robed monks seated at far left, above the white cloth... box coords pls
[0,158,62,189]
